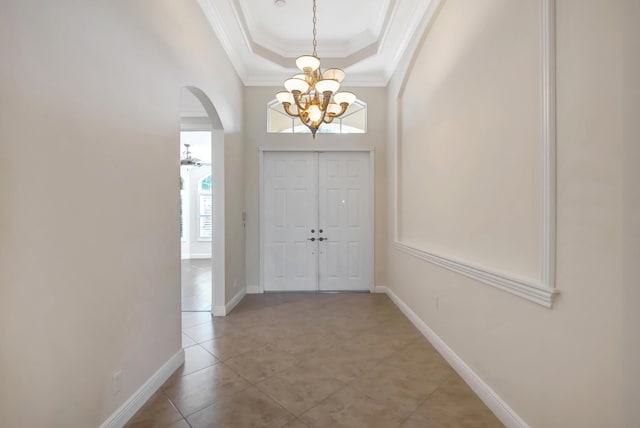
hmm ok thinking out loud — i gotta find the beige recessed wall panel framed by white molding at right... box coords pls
[397,1,543,282]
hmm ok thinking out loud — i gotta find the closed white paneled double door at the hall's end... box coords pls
[262,152,373,291]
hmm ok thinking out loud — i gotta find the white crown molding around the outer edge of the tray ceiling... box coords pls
[198,0,435,87]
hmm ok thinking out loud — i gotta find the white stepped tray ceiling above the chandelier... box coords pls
[198,0,431,86]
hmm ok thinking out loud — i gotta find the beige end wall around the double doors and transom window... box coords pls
[244,85,387,286]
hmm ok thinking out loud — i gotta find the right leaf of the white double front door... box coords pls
[318,152,372,291]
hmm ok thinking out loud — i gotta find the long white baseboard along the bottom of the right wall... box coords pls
[376,286,529,428]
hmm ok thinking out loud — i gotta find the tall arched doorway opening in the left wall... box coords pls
[180,86,225,312]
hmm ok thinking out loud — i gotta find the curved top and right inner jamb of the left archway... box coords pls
[180,86,225,315]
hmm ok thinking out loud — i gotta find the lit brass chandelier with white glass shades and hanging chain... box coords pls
[276,0,356,138]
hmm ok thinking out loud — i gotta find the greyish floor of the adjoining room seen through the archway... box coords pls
[182,259,211,311]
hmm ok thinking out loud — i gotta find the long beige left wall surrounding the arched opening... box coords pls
[0,0,244,427]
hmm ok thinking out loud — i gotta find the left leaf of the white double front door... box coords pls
[263,152,318,291]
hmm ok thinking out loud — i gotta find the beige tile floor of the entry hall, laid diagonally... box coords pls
[127,293,503,428]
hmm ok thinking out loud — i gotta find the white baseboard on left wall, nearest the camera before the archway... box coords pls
[100,349,184,428]
